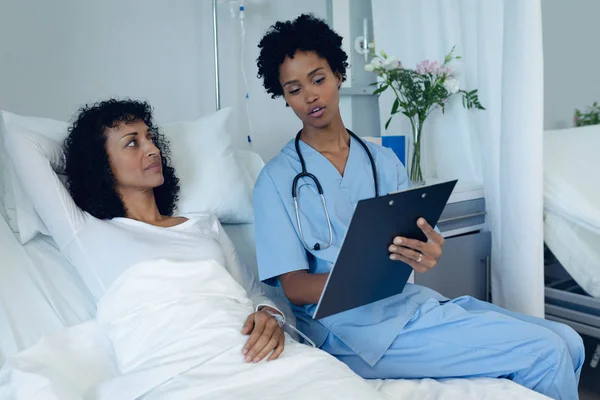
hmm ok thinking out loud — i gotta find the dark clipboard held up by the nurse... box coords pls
[313,180,458,319]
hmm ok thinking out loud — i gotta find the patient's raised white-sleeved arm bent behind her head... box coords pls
[5,128,86,250]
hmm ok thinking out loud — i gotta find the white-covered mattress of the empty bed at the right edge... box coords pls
[544,125,600,297]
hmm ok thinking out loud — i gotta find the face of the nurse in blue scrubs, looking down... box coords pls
[279,51,342,128]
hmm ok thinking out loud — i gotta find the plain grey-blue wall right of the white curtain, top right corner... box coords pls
[542,0,600,129]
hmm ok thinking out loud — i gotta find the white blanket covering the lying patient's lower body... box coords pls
[0,261,545,400]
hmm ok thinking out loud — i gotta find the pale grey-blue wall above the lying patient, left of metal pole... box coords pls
[0,0,214,122]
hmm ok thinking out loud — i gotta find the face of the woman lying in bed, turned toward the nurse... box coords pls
[105,121,164,193]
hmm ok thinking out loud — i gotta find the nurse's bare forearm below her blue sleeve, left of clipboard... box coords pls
[279,270,329,306]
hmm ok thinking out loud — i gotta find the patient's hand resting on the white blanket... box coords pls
[242,307,285,363]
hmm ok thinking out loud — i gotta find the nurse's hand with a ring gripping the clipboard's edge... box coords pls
[389,218,444,272]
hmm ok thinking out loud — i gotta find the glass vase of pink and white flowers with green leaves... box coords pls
[365,48,485,185]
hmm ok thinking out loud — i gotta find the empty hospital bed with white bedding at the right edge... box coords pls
[544,125,600,339]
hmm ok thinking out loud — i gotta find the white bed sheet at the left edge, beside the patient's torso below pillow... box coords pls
[0,217,95,366]
